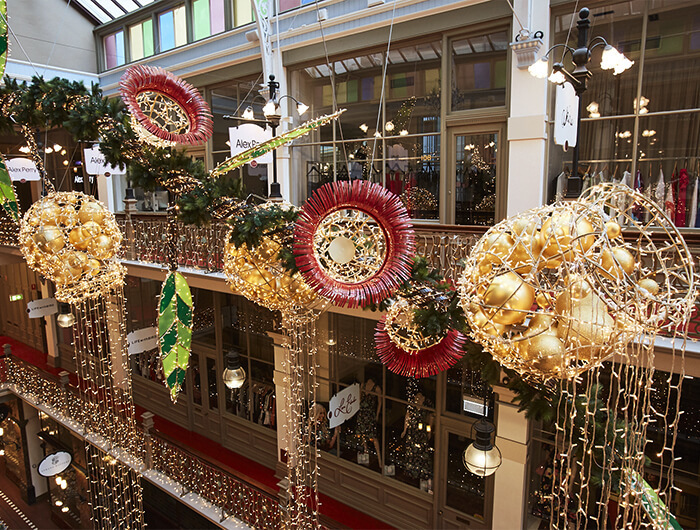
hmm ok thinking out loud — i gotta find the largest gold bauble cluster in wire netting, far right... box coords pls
[459,185,695,380]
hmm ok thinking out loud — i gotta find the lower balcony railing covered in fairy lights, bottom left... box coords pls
[0,347,283,530]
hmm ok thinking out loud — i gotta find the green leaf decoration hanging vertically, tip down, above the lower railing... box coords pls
[158,271,194,403]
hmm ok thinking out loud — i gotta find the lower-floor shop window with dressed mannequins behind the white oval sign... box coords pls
[309,313,436,491]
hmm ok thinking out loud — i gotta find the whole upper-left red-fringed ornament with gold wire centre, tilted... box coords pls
[119,65,213,147]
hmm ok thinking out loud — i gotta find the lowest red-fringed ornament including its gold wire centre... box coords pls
[374,298,466,378]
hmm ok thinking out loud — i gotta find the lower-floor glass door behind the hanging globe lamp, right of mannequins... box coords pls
[436,418,493,530]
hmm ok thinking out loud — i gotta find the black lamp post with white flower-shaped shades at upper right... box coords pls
[528,7,634,198]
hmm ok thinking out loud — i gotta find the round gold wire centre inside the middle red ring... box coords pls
[314,206,386,283]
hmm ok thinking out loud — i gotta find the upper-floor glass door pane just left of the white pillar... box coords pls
[448,128,505,226]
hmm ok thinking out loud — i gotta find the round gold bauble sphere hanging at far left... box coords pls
[19,192,126,303]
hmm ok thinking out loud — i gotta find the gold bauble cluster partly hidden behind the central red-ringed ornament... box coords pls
[224,205,325,314]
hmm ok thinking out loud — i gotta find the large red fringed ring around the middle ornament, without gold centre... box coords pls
[294,180,415,307]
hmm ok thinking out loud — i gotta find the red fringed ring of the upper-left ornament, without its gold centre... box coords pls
[119,65,213,145]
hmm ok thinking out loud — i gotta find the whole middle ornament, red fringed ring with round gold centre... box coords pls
[294,180,415,307]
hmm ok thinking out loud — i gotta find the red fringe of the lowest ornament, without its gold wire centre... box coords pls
[374,316,466,379]
